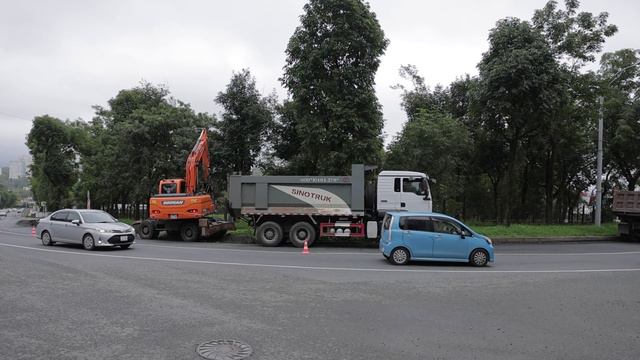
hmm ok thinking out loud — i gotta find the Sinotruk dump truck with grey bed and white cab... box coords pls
[227,164,432,247]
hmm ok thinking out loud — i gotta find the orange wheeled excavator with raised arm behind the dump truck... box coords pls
[140,129,234,241]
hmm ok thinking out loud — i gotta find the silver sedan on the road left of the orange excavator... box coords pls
[36,209,135,250]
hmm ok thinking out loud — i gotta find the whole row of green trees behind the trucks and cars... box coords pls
[27,0,640,223]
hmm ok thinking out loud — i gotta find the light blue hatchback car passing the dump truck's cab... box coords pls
[380,212,495,266]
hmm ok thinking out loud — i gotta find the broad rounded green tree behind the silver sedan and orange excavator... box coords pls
[79,83,214,217]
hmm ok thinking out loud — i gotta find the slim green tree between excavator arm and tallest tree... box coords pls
[215,69,274,179]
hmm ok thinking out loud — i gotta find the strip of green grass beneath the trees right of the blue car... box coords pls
[471,223,618,237]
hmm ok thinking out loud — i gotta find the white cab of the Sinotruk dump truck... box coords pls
[376,171,432,216]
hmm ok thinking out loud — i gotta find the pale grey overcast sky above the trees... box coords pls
[0,0,640,166]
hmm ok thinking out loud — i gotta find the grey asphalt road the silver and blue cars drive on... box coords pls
[0,219,640,359]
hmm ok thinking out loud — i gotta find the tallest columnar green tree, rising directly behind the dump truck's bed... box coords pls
[281,0,388,174]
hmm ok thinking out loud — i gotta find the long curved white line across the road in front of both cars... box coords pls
[0,243,640,274]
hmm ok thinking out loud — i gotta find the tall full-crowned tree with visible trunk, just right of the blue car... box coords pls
[478,18,562,224]
